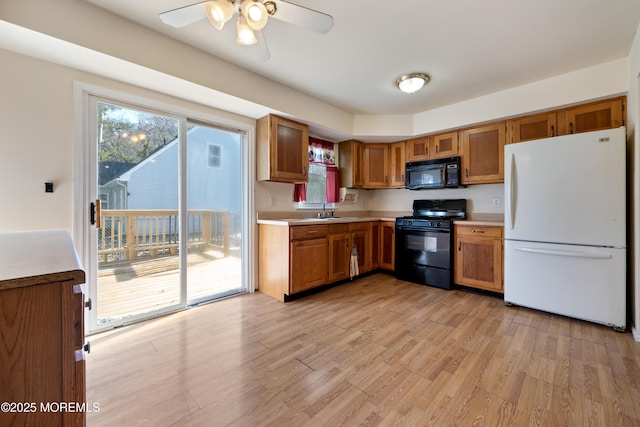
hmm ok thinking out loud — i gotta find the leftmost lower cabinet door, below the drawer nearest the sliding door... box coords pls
[290,238,328,294]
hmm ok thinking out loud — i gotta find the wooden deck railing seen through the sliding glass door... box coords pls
[98,209,231,262]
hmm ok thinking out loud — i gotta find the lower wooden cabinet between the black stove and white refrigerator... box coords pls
[454,224,503,292]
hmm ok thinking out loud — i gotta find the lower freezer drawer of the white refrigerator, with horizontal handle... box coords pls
[504,240,627,329]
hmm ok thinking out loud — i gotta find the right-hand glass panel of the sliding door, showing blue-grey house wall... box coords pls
[186,122,243,304]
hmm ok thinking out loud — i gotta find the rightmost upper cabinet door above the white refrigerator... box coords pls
[566,98,625,133]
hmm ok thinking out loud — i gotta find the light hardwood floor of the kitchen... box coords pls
[87,274,640,427]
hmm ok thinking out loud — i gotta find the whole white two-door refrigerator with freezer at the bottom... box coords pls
[504,127,627,330]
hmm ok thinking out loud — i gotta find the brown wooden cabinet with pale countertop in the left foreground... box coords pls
[0,230,86,426]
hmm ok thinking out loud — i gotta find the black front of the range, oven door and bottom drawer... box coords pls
[395,225,453,289]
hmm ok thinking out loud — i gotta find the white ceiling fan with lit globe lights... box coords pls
[160,0,333,60]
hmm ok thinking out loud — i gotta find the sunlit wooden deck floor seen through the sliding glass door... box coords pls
[97,251,242,323]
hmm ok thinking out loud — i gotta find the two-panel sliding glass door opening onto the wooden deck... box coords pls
[86,97,247,331]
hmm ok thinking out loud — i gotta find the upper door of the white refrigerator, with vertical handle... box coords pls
[504,127,626,248]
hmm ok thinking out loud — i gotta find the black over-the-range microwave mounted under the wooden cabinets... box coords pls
[404,156,460,190]
